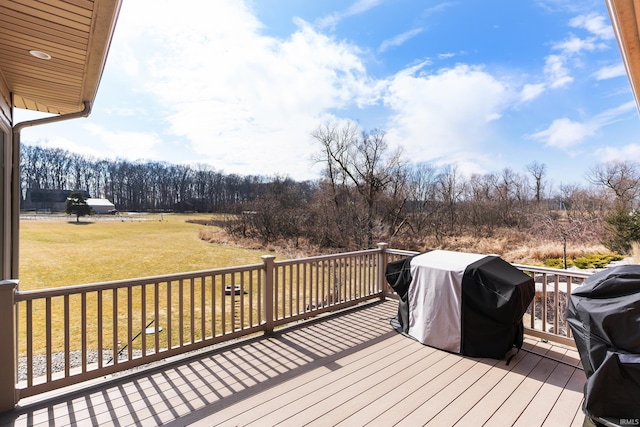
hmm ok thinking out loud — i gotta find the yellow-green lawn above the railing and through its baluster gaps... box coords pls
[19,214,268,355]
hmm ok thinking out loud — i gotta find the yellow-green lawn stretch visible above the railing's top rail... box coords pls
[20,214,269,290]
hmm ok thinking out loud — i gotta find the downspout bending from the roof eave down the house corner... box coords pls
[10,101,91,279]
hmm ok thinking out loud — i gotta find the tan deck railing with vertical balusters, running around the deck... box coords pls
[0,244,588,411]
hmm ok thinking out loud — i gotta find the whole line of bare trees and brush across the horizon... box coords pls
[21,121,640,252]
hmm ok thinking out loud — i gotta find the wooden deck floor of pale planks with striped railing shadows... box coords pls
[0,301,585,427]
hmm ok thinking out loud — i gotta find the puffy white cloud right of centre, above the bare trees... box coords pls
[385,65,511,169]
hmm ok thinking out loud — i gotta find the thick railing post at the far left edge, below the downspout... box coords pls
[0,280,18,412]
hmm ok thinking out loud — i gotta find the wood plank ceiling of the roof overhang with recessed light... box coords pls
[0,0,121,114]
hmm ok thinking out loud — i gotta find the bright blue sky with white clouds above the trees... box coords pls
[17,0,640,187]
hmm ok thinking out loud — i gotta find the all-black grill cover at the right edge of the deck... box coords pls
[567,265,640,420]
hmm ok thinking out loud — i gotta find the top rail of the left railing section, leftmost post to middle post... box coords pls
[15,264,264,302]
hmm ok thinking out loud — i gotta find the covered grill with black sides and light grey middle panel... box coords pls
[386,251,535,359]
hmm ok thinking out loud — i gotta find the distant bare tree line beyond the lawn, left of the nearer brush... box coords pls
[20,144,265,212]
